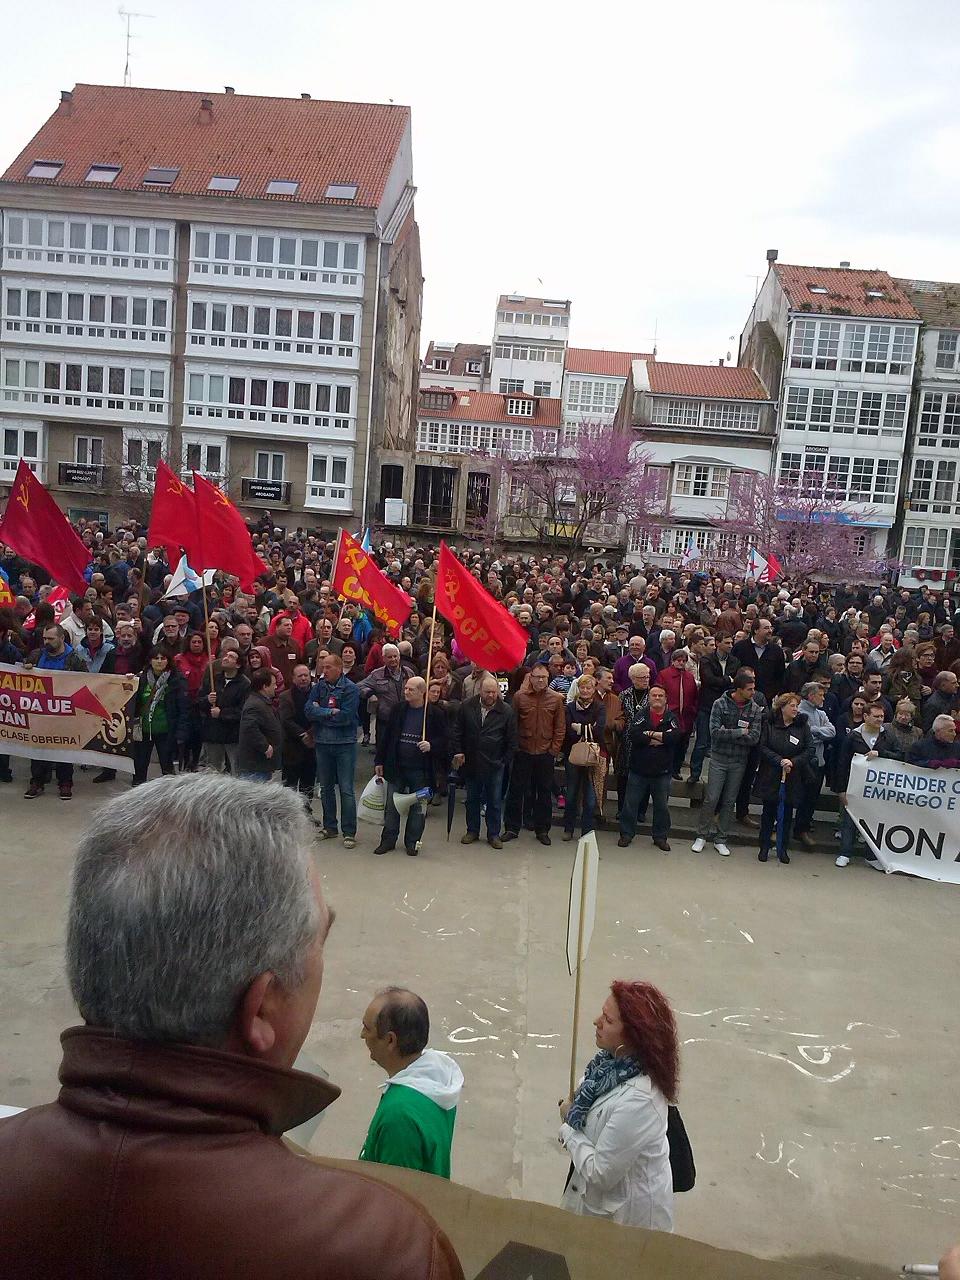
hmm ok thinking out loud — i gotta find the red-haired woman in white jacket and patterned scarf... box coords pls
[559,982,680,1231]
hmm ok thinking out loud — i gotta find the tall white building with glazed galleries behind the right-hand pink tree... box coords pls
[740,257,920,556]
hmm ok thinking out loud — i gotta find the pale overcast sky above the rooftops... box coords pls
[0,0,960,361]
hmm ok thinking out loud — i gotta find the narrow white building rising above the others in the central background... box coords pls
[489,293,570,399]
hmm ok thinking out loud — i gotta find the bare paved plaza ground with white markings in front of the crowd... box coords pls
[0,754,960,1277]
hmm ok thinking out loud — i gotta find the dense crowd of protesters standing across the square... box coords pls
[0,515,960,867]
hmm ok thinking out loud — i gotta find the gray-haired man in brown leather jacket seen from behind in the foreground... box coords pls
[0,773,462,1280]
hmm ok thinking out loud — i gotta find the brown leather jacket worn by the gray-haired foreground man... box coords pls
[0,1027,463,1280]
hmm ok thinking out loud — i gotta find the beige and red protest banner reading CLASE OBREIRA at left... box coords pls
[0,663,140,773]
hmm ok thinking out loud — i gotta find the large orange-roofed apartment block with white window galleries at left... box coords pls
[0,84,421,529]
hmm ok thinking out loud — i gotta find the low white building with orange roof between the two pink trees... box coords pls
[614,357,776,567]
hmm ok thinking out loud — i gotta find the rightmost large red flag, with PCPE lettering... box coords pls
[435,543,527,671]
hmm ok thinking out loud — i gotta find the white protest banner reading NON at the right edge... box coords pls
[846,755,960,884]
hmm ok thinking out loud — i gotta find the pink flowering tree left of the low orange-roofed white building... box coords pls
[490,424,664,558]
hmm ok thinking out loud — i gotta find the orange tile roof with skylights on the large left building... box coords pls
[4,84,410,209]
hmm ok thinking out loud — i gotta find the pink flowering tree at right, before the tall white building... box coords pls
[710,475,896,580]
